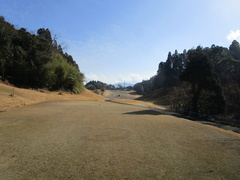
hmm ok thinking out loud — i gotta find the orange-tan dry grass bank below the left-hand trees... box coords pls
[0,83,105,112]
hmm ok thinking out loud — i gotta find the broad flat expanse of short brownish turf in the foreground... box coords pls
[0,101,240,180]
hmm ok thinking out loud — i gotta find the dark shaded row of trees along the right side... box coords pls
[134,40,240,119]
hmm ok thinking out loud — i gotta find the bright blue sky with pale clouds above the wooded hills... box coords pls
[0,0,240,84]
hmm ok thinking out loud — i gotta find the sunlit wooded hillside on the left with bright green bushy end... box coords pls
[0,16,84,93]
